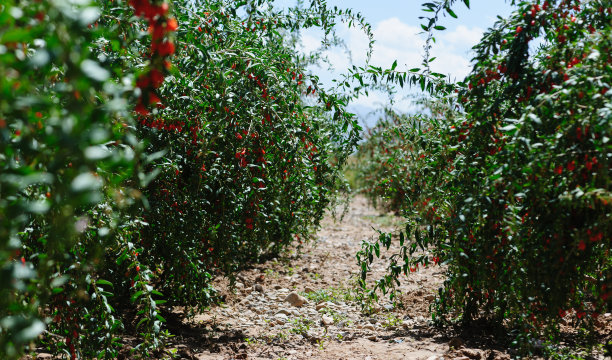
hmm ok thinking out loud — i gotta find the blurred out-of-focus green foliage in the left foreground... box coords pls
[0,1,152,358]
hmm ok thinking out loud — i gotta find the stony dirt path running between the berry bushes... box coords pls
[169,197,509,360]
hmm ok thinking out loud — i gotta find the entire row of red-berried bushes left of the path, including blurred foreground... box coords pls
[0,0,369,359]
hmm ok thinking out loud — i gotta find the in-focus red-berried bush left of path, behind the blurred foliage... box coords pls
[138,2,358,312]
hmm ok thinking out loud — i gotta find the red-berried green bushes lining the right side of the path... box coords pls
[359,1,612,352]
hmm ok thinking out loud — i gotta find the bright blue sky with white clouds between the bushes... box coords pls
[277,0,512,125]
